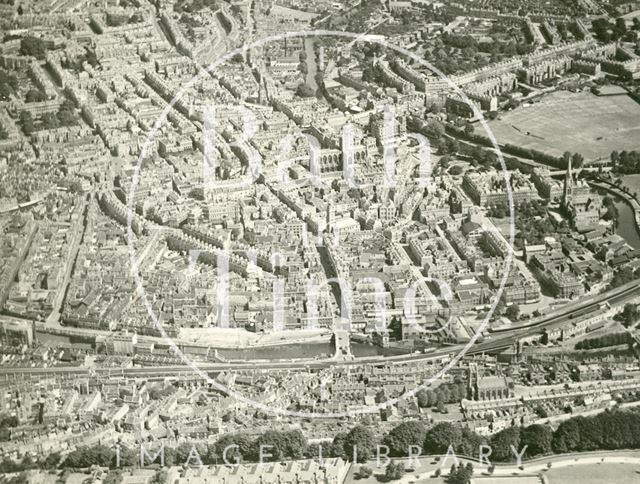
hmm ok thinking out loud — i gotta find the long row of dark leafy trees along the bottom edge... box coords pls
[13,410,640,472]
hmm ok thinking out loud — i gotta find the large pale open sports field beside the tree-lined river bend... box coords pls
[489,91,640,161]
